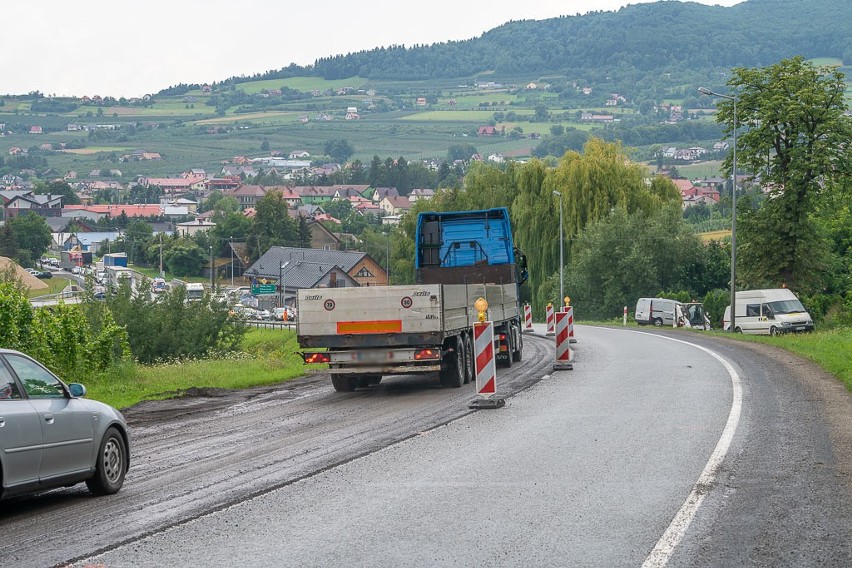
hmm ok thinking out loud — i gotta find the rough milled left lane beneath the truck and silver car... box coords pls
[0,337,553,568]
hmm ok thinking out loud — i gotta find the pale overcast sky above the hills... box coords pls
[0,0,742,98]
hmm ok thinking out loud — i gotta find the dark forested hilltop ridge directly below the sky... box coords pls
[245,0,852,82]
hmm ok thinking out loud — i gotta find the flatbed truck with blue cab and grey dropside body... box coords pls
[297,208,526,391]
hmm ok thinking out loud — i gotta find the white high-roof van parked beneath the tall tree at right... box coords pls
[723,288,814,335]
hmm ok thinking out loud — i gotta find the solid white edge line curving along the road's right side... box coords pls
[624,330,743,568]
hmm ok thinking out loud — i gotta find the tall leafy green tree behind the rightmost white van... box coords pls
[717,57,852,292]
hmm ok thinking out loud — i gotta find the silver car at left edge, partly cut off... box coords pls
[0,349,130,498]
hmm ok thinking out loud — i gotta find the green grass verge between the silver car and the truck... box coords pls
[86,329,305,408]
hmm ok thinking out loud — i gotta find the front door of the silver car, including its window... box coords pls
[6,354,95,481]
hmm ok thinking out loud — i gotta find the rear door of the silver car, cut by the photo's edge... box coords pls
[0,356,42,488]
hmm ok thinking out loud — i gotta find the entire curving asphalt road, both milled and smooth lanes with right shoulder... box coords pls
[0,326,852,568]
